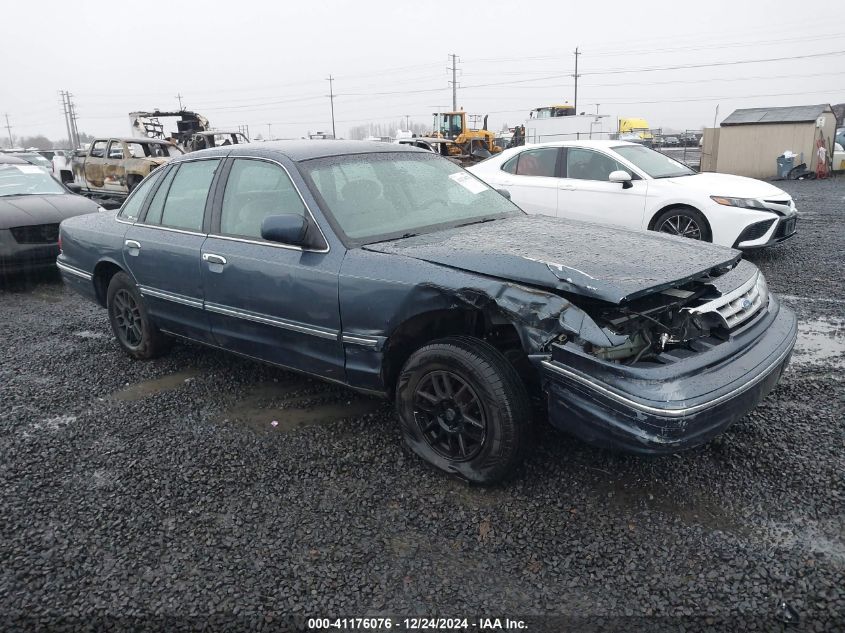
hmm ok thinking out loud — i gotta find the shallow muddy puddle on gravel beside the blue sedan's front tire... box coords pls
[218,379,384,433]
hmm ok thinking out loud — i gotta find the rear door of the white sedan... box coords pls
[496,147,560,215]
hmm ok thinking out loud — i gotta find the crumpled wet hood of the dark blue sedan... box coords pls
[364,215,741,303]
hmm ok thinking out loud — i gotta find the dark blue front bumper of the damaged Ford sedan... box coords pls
[541,296,797,454]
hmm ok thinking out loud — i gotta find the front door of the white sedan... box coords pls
[558,147,648,229]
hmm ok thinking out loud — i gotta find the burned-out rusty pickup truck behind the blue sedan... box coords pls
[71,138,182,198]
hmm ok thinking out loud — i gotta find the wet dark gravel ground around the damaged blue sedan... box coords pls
[0,178,845,631]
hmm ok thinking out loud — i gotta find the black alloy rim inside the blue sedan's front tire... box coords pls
[414,371,487,461]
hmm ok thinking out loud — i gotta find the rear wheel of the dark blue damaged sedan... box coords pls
[106,272,169,360]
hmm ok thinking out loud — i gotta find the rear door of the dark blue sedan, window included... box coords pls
[124,158,222,342]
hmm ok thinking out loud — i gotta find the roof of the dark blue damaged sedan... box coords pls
[179,139,431,162]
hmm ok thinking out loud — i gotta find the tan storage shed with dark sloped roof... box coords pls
[702,103,836,178]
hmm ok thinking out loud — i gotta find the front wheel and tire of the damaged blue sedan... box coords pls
[396,337,531,484]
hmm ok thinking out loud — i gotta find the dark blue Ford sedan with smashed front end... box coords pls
[58,141,796,483]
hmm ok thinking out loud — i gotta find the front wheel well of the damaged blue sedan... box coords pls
[382,309,528,395]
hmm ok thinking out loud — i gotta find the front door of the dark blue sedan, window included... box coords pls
[201,158,344,380]
